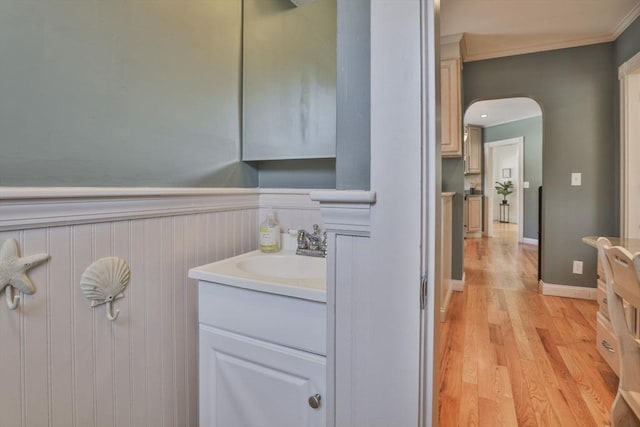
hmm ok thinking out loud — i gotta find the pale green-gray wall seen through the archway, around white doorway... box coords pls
[482,116,542,240]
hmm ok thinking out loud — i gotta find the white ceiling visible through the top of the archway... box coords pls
[464,97,542,127]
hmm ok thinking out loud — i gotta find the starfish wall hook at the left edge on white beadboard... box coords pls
[0,239,50,310]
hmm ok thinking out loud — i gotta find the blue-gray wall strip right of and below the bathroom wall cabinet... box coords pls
[259,0,370,191]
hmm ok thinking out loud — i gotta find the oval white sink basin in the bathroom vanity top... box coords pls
[237,254,326,280]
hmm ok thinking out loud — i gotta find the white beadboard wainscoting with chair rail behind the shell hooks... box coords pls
[0,187,319,427]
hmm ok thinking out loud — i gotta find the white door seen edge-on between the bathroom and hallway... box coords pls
[420,0,440,427]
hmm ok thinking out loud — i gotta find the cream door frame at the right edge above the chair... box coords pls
[618,53,640,238]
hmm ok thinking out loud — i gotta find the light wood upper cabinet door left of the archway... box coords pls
[440,59,462,157]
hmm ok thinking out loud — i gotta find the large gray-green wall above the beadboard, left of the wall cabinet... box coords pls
[0,0,258,187]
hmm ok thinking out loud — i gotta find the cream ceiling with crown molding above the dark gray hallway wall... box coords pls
[440,0,640,61]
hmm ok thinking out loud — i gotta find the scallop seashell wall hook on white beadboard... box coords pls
[80,257,131,321]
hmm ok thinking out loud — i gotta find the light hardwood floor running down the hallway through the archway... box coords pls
[440,225,618,427]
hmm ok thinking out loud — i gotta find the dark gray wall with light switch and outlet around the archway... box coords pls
[463,43,617,287]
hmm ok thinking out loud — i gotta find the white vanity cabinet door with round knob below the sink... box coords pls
[200,325,326,427]
